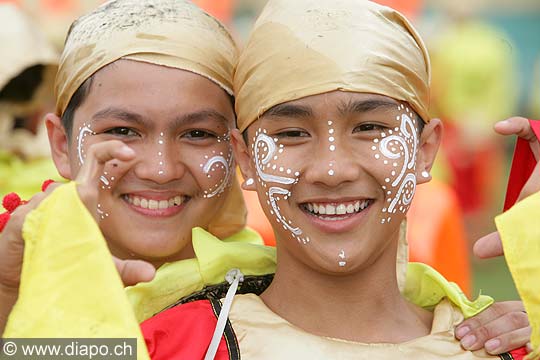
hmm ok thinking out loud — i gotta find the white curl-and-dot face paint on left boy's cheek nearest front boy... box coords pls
[200,133,233,199]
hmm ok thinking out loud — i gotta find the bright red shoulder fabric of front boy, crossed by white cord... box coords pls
[141,300,229,360]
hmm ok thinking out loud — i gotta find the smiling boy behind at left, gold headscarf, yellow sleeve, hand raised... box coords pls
[0,0,275,344]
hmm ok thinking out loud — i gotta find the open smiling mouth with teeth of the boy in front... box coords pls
[300,199,373,221]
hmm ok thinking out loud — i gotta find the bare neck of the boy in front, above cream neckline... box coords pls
[261,236,432,343]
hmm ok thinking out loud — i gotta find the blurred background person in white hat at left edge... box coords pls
[0,4,59,198]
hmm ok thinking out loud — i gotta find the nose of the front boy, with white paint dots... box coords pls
[304,136,361,187]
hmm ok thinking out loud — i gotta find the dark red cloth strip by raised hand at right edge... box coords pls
[504,120,540,211]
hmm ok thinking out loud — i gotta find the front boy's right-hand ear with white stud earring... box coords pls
[416,119,443,184]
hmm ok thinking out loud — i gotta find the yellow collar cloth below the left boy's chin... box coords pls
[126,228,275,322]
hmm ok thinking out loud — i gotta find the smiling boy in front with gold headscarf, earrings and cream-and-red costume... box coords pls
[142,0,525,359]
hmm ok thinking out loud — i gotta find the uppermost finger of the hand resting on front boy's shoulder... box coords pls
[455,301,525,339]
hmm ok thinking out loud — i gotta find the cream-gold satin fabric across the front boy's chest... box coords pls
[229,294,498,360]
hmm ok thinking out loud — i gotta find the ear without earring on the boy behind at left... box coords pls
[45,113,72,179]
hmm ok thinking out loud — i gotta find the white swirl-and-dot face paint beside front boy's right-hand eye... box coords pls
[372,104,418,224]
